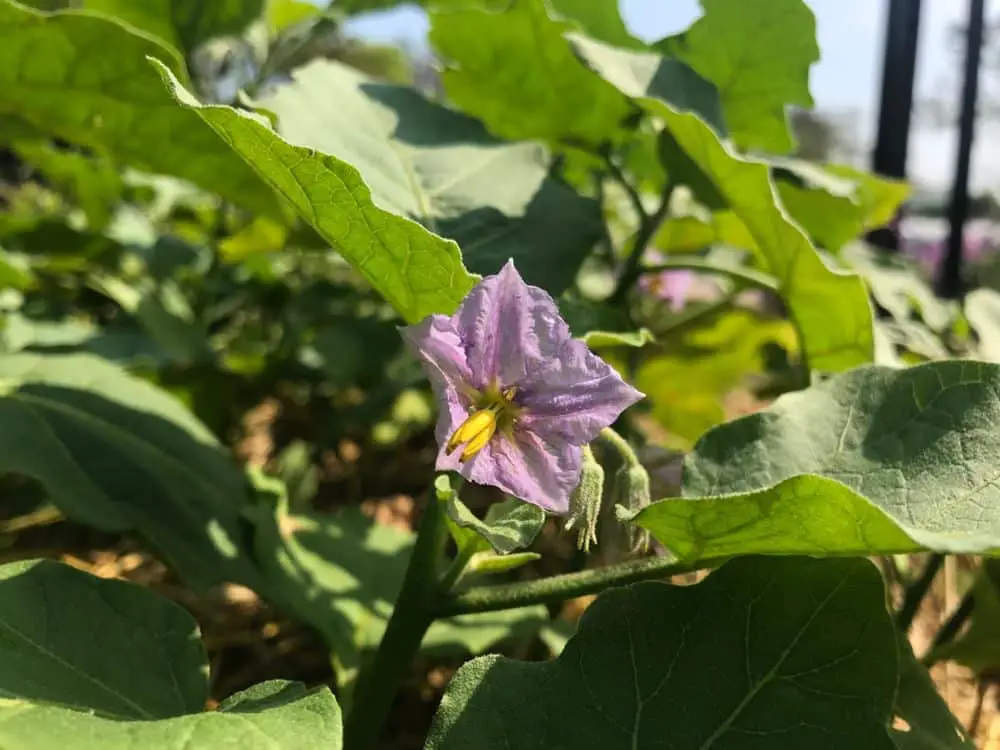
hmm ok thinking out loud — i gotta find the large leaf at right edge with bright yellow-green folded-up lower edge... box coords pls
[636,361,1000,558]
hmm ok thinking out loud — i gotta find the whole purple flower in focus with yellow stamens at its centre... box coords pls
[403,261,642,513]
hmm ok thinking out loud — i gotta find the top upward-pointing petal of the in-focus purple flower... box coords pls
[454,261,570,389]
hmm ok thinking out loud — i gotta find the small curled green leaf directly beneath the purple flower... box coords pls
[444,477,545,555]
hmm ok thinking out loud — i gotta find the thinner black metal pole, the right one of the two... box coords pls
[937,0,986,298]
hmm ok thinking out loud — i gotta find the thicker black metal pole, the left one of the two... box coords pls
[868,0,921,250]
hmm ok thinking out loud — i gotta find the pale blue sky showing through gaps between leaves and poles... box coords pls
[342,0,1000,194]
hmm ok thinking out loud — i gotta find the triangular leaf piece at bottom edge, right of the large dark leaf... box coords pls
[892,636,976,750]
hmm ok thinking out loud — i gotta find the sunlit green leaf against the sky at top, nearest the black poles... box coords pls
[657,0,819,154]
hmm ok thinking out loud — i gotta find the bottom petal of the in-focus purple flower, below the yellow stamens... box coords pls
[458,430,583,514]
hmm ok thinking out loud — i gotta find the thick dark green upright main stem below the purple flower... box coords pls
[344,492,448,750]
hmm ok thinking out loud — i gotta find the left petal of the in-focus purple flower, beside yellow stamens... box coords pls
[401,315,472,471]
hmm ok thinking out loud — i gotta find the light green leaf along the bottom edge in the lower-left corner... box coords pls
[0,680,343,750]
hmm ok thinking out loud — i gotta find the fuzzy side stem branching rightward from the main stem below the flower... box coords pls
[437,555,727,617]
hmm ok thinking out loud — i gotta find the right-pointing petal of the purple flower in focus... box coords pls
[518,339,644,445]
